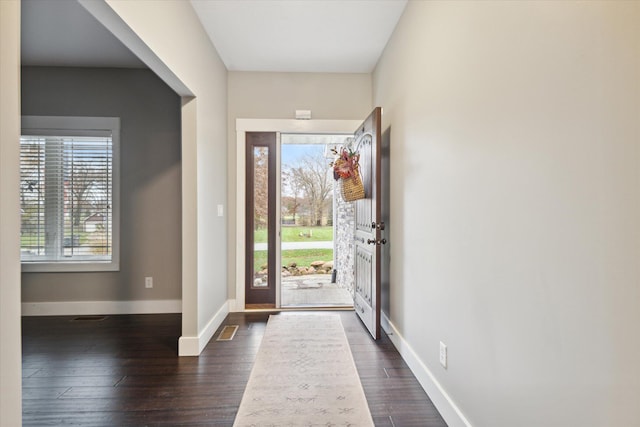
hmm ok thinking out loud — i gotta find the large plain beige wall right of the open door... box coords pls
[373,1,640,427]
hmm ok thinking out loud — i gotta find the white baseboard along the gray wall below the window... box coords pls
[22,299,182,316]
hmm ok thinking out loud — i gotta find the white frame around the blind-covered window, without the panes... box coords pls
[20,116,120,272]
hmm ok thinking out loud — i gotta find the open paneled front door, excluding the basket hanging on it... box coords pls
[353,107,386,339]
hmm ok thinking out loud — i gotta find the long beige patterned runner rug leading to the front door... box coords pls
[233,314,373,427]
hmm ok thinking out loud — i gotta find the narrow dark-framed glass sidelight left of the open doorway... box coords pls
[245,132,277,306]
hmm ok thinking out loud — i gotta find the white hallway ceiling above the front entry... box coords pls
[191,0,406,73]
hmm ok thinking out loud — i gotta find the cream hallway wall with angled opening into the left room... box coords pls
[82,0,227,354]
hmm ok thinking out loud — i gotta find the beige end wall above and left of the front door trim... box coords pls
[227,71,373,298]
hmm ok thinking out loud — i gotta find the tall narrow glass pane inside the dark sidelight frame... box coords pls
[252,147,269,288]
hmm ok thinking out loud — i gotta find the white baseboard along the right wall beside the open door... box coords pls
[381,313,472,427]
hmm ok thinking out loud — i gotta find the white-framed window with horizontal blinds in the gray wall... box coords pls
[20,116,119,271]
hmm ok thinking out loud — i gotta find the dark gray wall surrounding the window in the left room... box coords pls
[22,67,182,302]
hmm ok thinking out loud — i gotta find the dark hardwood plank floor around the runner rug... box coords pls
[22,311,446,427]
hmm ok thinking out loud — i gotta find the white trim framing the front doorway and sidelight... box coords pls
[236,119,362,312]
